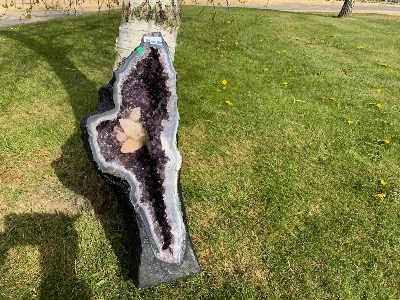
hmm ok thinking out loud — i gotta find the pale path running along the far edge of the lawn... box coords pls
[0,3,400,27]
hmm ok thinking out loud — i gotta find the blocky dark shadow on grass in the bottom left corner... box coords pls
[0,213,91,300]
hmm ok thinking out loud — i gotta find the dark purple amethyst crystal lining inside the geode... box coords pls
[96,48,173,250]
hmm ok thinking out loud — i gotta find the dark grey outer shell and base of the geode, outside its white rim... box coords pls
[81,35,200,288]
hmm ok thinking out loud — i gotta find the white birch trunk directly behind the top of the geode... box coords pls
[114,0,181,70]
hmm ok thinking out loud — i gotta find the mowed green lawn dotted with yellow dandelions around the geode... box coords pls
[0,7,400,299]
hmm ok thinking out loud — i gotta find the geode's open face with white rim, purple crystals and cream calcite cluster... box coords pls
[86,33,186,264]
